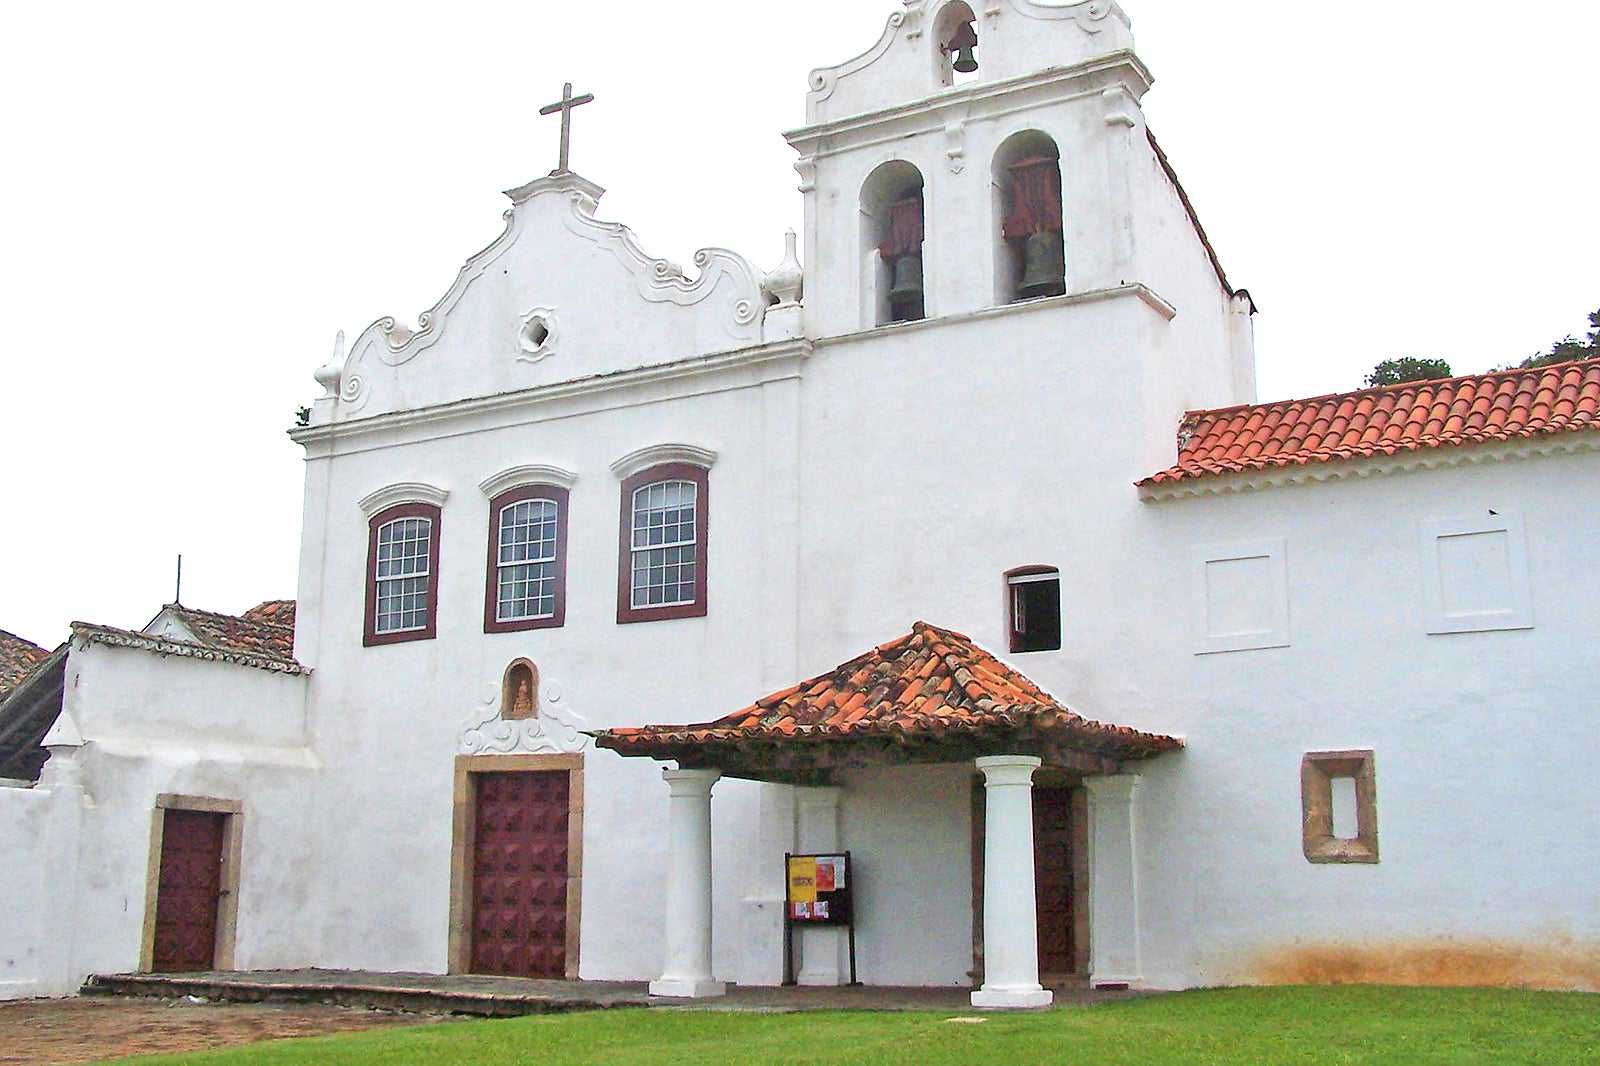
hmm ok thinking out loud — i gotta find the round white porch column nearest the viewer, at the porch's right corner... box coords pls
[973,755,1054,1007]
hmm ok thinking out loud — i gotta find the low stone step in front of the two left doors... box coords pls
[83,970,651,1018]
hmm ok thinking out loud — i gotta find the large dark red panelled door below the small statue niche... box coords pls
[472,771,568,978]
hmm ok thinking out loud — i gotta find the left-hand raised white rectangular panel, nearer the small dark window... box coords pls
[1192,539,1290,655]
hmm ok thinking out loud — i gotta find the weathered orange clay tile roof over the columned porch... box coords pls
[595,623,1182,759]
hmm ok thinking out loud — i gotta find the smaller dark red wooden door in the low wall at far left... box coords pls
[150,810,227,973]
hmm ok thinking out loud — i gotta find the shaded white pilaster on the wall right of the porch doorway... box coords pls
[1083,775,1144,988]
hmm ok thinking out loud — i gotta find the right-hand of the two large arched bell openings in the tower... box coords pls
[994,130,1067,304]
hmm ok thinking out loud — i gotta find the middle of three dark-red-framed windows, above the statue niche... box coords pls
[483,485,570,632]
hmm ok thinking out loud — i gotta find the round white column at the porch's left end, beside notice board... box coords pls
[650,770,728,999]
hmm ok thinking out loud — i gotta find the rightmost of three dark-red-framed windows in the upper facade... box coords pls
[616,463,710,623]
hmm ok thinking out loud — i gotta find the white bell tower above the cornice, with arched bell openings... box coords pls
[786,0,1254,419]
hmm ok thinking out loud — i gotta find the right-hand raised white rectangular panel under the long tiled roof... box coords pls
[1422,512,1533,634]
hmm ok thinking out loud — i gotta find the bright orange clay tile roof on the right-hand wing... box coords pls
[1139,359,1600,487]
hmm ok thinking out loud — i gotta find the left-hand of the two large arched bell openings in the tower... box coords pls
[861,160,928,325]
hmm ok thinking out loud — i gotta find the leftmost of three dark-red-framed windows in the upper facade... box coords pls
[365,503,440,647]
